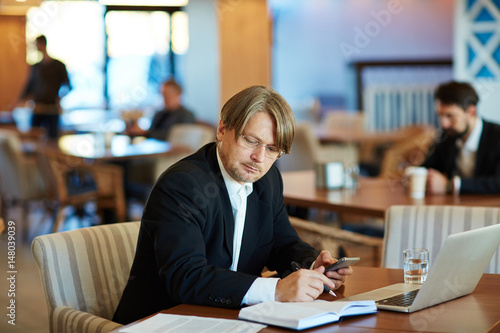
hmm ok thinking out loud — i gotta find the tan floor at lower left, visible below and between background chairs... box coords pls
[0,203,142,333]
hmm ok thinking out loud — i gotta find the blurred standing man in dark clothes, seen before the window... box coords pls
[21,35,71,139]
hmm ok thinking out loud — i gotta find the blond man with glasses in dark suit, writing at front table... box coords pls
[113,86,352,324]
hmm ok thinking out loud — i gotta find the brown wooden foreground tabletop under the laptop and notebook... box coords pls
[115,267,500,333]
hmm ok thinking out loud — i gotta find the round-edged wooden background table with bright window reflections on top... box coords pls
[34,133,191,221]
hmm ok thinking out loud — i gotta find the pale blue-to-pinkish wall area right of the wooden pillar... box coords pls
[269,0,454,116]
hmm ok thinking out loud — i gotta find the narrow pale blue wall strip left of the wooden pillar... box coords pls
[183,0,220,124]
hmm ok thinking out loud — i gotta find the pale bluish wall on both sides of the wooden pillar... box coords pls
[184,0,455,123]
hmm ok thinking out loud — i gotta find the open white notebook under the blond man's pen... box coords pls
[238,300,377,330]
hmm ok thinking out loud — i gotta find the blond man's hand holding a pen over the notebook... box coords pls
[275,266,335,302]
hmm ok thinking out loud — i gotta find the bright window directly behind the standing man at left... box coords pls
[26,1,106,110]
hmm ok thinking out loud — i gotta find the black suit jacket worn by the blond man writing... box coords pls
[113,143,318,324]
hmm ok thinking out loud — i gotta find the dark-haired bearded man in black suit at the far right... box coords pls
[423,81,500,194]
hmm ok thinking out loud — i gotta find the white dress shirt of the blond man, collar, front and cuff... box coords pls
[217,147,279,305]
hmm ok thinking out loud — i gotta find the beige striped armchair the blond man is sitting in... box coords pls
[32,222,140,333]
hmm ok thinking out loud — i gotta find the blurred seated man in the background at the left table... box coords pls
[126,79,195,141]
